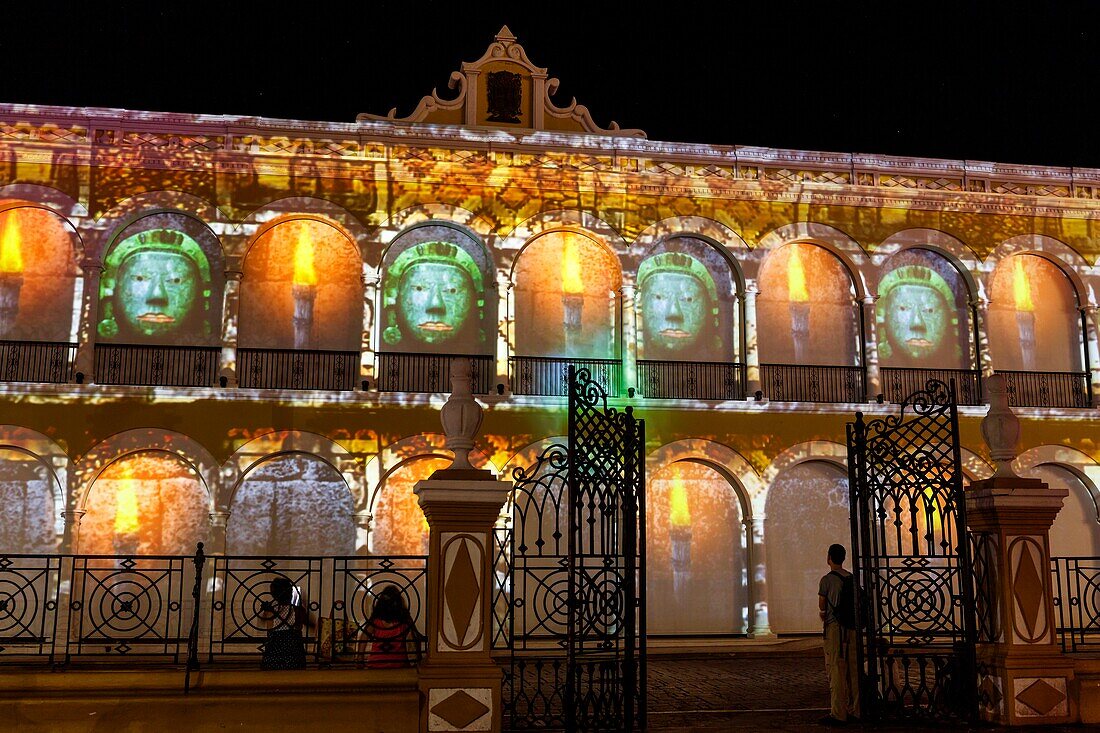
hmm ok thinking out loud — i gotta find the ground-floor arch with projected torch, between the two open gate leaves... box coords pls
[646,460,749,634]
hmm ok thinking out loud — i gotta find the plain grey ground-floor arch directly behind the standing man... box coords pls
[765,460,851,634]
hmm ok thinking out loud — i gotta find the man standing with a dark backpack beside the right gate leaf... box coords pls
[817,545,859,725]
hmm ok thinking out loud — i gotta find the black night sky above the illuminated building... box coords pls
[8,0,1100,167]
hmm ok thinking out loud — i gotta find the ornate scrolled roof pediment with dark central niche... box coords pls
[355,25,646,138]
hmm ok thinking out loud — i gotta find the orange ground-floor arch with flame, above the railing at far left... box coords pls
[81,450,210,555]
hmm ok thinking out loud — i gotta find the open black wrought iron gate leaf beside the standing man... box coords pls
[848,380,977,720]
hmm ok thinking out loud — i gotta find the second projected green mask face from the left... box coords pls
[397,262,473,343]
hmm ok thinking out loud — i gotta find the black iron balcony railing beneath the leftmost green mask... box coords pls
[96,343,221,386]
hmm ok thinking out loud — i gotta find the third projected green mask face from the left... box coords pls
[641,272,707,351]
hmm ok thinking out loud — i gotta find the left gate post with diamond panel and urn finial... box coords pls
[415,359,512,733]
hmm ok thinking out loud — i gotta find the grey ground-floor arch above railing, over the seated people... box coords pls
[226,452,355,556]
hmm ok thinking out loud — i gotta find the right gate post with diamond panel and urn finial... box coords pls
[966,374,1077,725]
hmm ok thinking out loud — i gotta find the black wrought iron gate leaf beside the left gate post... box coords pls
[494,367,646,731]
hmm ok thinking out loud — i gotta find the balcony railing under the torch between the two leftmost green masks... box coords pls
[237,349,359,391]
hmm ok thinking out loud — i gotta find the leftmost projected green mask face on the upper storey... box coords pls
[114,246,199,336]
